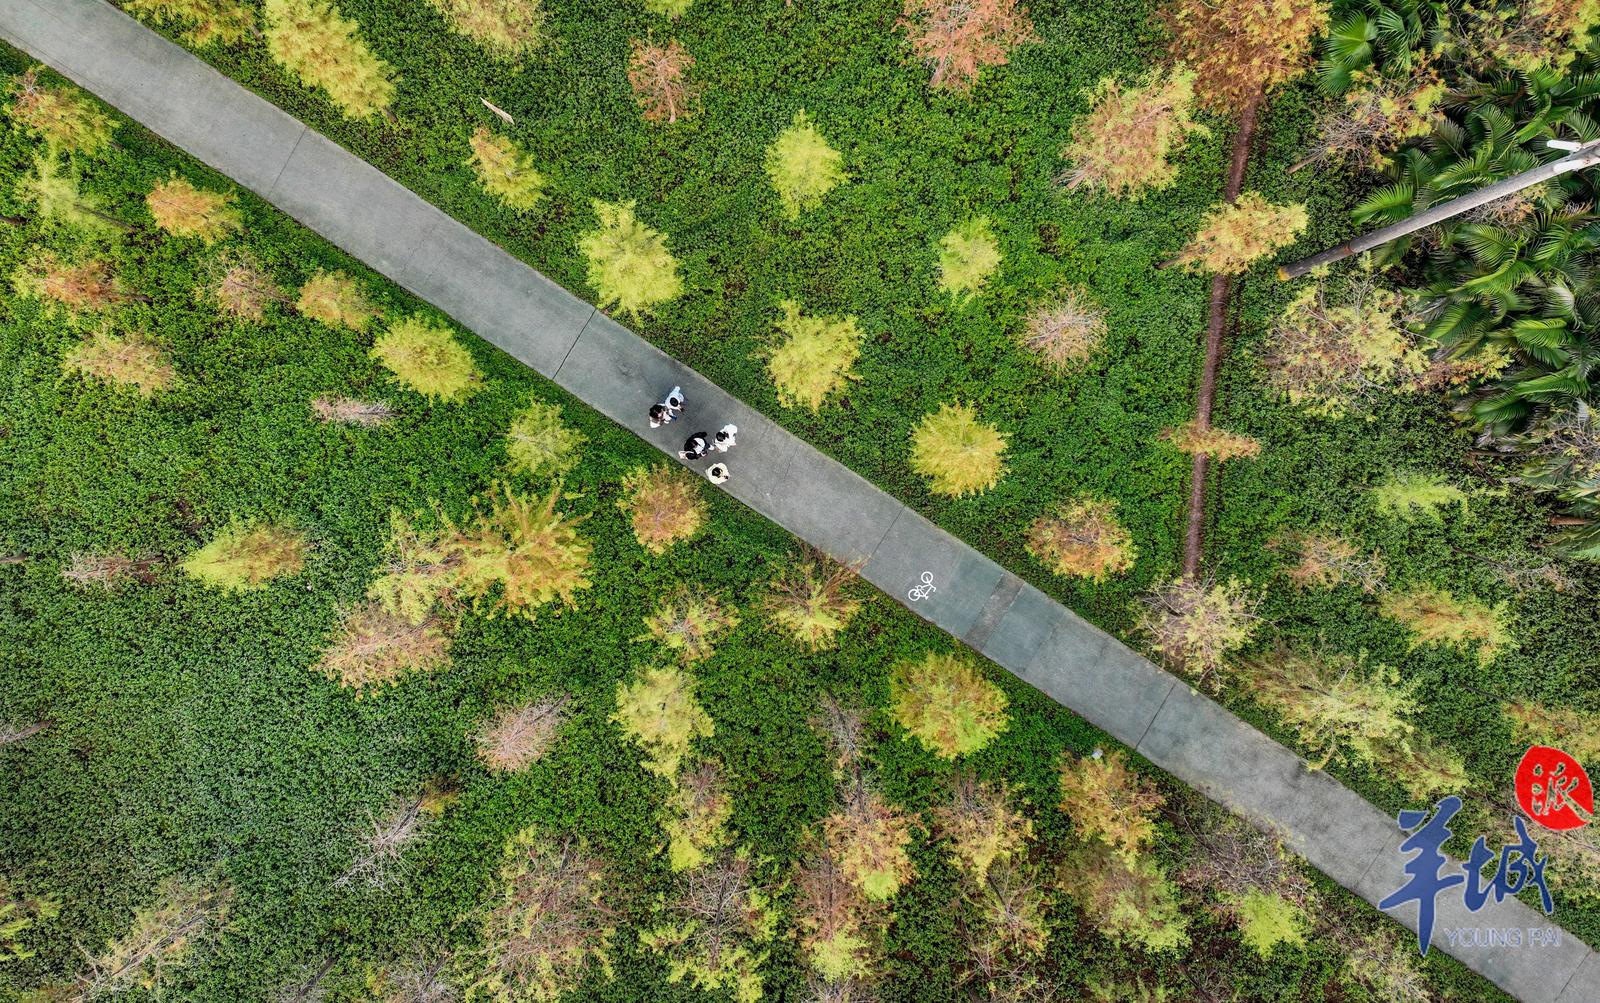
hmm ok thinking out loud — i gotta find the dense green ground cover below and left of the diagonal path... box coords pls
[0,50,1494,1001]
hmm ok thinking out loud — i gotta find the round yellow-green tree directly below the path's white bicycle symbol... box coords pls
[890,653,1008,760]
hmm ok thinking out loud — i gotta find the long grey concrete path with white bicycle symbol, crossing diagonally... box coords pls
[0,0,1600,1003]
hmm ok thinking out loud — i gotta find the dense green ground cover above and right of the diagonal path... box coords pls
[109,0,1600,937]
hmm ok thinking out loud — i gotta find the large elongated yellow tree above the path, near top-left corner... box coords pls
[262,0,395,118]
